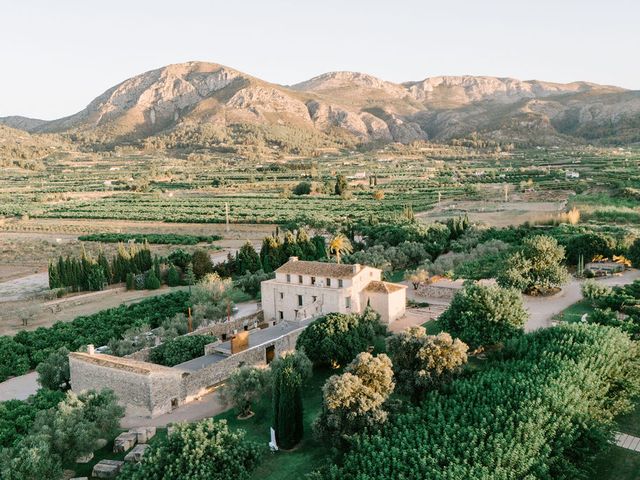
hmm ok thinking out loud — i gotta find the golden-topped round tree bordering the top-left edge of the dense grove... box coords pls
[387,326,469,400]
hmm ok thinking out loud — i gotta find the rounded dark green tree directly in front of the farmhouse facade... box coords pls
[296,308,385,366]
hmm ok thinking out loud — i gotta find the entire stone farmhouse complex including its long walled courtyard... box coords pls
[69,257,406,418]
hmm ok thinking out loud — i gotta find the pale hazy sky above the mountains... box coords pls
[0,0,640,119]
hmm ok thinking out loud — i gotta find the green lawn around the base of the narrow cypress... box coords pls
[215,369,336,480]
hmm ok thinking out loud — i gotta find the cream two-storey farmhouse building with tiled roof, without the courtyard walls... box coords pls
[261,257,407,324]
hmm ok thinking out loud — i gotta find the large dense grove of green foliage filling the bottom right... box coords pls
[316,325,640,480]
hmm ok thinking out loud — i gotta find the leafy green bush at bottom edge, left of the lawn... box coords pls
[118,419,265,480]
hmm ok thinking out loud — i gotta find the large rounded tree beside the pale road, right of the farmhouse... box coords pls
[497,235,569,294]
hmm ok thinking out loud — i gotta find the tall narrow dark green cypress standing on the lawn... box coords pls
[271,352,311,450]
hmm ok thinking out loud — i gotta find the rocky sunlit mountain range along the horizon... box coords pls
[0,62,640,145]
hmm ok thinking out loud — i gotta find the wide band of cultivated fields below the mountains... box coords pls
[0,146,640,224]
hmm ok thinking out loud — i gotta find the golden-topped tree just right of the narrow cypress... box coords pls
[313,352,395,446]
